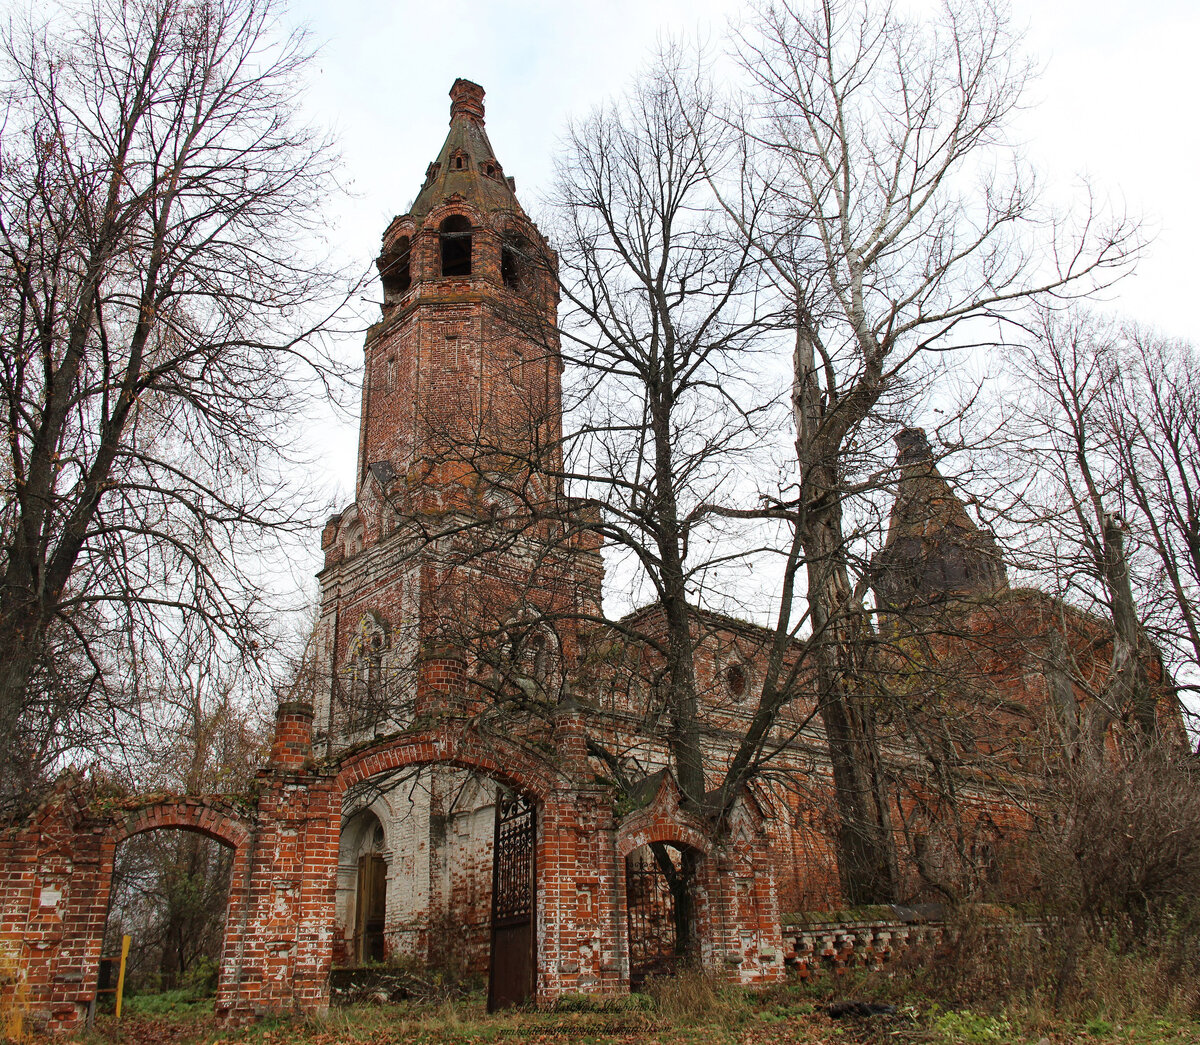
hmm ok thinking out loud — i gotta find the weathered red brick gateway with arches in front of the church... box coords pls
[0,701,778,1029]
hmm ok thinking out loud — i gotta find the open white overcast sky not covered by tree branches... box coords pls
[293,0,1200,498]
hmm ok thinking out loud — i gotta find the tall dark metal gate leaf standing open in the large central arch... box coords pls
[487,791,538,1013]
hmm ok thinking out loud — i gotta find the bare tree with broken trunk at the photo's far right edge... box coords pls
[1009,311,1200,759]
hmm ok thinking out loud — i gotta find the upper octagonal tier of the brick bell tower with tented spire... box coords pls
[358,79,562,511]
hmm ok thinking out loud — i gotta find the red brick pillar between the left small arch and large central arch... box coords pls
[217,759,342,1020]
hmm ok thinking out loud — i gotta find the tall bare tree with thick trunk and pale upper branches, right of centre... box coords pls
[726,0,1138,902]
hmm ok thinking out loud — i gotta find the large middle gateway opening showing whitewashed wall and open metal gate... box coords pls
[334,740,545,1010]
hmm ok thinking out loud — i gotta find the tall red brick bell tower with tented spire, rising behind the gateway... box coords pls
[314,79,601,752]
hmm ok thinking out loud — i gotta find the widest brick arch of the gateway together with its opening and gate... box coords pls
[335,721,564,1010]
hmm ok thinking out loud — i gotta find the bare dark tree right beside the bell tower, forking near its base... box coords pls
[544,49,825,835]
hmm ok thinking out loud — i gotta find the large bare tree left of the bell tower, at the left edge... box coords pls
[0,0,350,799]
